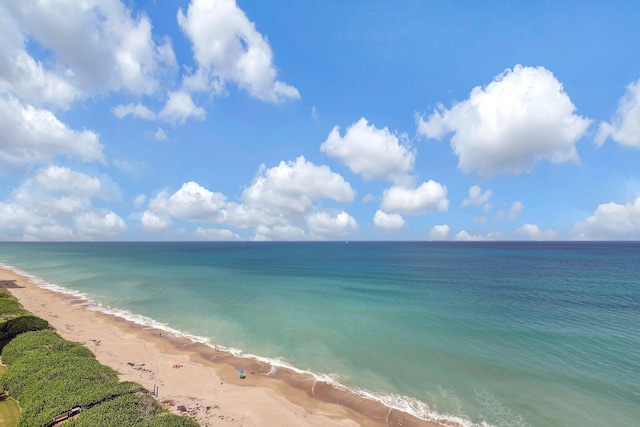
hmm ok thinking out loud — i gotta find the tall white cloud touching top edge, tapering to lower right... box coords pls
[178,0,300,103]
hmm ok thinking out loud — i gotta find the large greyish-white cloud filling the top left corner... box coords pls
[0,0,175,108]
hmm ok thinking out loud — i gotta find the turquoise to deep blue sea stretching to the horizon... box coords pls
[0,242,640,427]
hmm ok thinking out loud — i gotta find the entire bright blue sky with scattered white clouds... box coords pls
[0,0,640,241]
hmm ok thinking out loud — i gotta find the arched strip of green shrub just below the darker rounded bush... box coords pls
[2,330,94,365]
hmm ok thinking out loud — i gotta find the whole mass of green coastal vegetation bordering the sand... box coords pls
[0,289,198,427]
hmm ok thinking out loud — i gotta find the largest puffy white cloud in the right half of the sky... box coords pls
[418,65,591,176]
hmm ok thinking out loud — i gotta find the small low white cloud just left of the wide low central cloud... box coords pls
[149,181,226,221]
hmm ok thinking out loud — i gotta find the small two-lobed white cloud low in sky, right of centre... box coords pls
[381,180,449,215]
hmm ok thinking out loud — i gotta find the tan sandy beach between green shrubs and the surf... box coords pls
[0,269,439,427]
